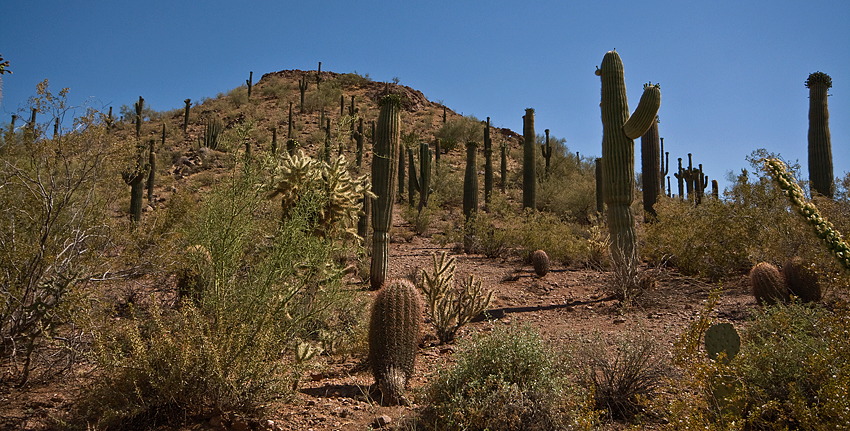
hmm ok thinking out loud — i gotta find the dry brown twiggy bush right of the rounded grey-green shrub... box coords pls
[573,331,672,420]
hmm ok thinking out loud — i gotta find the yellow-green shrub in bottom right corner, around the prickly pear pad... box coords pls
[668,302,850,430]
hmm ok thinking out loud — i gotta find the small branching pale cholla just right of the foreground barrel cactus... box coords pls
[421,252,493,343]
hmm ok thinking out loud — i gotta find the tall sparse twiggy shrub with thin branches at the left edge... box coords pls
[0,80,121,384]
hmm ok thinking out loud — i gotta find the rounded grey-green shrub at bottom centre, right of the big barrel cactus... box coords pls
[423,325,596,430]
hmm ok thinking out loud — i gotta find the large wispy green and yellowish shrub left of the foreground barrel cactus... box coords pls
[81,164,349,427]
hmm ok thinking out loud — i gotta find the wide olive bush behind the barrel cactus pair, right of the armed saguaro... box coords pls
[642,150,847,280]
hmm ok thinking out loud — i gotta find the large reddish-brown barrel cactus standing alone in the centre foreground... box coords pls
[369,279,423,405]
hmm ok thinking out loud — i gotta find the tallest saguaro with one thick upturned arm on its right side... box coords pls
[596,51,661,264]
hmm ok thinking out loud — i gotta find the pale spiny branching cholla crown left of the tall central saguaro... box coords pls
[267,150,371,240]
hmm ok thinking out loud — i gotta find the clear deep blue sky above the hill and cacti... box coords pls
[0,0,850,189]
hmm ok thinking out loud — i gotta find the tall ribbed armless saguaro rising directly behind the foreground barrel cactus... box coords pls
[369,94,401,290]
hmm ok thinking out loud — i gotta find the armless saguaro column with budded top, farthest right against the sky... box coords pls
[806,72,835,199]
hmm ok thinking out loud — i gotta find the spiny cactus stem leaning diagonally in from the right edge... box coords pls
[764,158,850,269]
